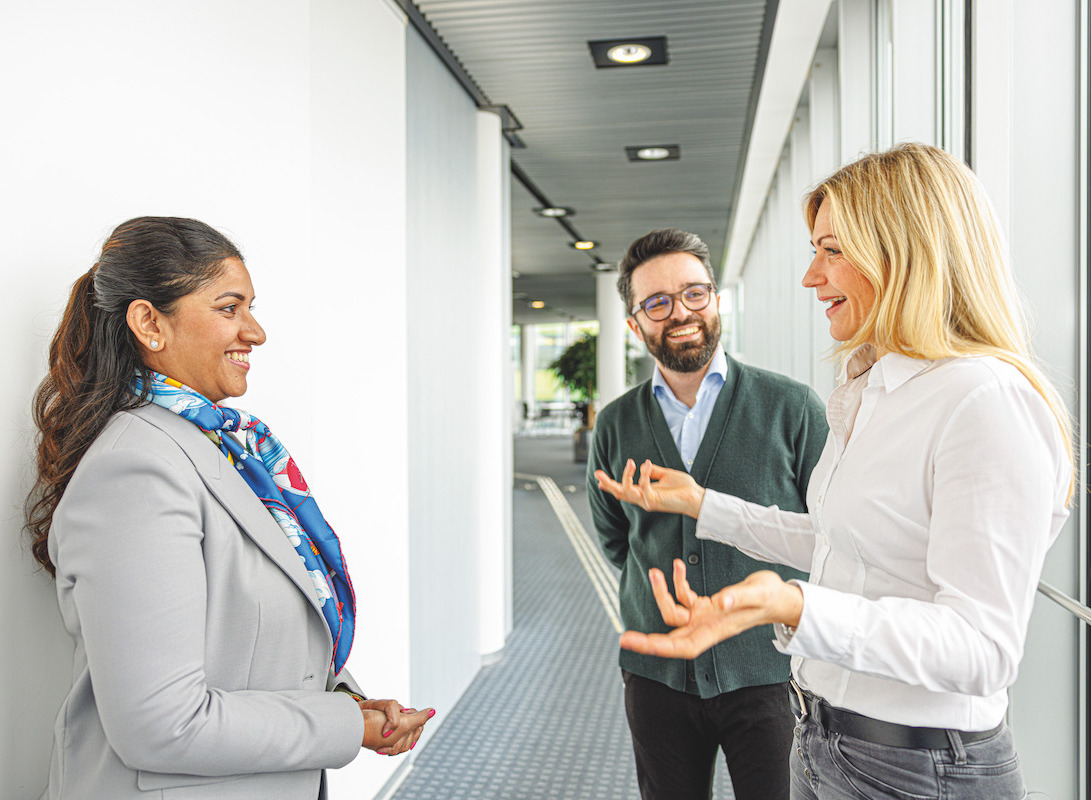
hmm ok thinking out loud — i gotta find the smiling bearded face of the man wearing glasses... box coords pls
[628,253,720,372]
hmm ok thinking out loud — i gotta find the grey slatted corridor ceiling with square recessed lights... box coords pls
[416,0,777,322]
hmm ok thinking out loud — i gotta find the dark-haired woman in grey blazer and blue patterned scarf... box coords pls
[27,217,434,800]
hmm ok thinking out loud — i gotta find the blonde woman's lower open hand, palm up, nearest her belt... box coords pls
[621,559,803,658]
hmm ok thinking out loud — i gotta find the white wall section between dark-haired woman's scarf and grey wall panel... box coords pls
[309,0,414,798]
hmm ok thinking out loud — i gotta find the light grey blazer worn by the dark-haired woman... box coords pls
[43,405,363,800]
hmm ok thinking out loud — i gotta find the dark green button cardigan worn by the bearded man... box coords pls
[587,356,828,697]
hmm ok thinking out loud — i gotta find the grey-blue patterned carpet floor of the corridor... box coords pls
[392,437,733,800]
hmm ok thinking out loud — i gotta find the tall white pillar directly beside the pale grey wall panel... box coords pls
[472,111,513,654]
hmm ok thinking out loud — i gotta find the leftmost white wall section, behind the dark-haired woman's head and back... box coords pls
[0,0,312,799]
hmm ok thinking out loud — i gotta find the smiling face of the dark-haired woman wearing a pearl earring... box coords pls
[137,259,265,403]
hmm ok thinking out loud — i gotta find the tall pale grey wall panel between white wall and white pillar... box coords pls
[405,24,482,708]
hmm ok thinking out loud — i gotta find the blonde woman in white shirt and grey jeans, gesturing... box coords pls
[597,144,1072,800]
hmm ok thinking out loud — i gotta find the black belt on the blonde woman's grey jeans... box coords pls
[788,680,1004,750]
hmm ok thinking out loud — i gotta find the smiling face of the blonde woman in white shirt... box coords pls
[803,200,875,342]
